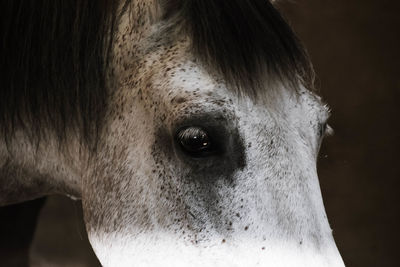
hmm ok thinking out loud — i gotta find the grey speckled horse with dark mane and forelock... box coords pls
[0,0,344,267]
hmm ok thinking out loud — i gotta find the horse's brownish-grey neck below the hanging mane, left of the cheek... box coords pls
[0,132,87,206]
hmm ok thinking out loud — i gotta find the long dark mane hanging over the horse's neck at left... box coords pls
[0,0,124,149]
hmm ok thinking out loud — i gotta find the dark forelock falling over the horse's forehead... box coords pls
[160,0,314,99]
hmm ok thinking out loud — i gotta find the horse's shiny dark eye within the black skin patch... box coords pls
[176,126,215,157]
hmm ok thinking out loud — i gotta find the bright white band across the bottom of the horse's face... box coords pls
[89,233,344,267]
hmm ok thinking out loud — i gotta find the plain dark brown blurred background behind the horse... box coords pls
[0,0,400,267]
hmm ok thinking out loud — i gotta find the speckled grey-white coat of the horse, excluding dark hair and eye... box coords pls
[0,1,343,267]
